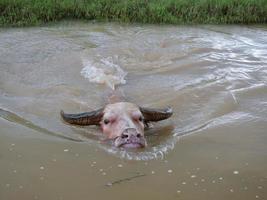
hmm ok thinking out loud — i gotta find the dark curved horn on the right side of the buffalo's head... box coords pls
[140,107,173,122]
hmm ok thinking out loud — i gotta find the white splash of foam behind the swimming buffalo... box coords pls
[81,57,127,90]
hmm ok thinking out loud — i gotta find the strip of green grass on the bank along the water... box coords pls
[0,0,267,26]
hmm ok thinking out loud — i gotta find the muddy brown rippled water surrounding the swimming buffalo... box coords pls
[0,22,267,200]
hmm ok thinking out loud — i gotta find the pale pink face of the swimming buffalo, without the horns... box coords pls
[100,102,146,148]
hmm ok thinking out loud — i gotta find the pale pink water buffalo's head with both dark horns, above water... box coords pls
[61,102,173,148]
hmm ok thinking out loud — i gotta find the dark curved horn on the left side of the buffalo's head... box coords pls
[60,108,103,126]
